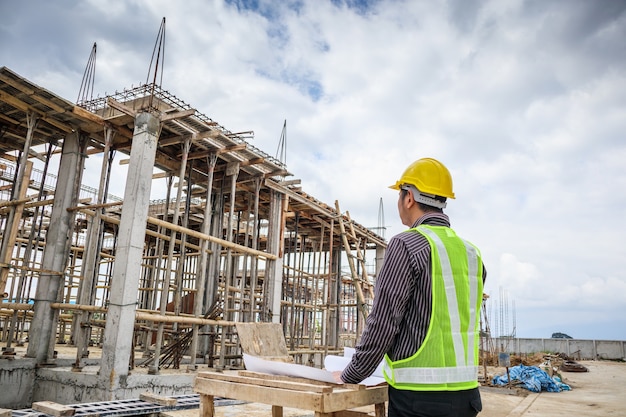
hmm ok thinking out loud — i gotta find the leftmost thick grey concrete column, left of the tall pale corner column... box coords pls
[26,132,85,364]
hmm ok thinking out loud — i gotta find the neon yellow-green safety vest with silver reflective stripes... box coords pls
[383,225,483,391]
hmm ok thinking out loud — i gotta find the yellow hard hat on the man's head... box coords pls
[389,158,454,198]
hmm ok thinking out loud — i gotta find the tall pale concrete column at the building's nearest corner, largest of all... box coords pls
[100,113,160,394]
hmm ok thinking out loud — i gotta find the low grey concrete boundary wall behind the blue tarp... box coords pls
[502,338,626,360]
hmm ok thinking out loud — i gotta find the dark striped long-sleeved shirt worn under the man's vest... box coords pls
[341,212,486,384]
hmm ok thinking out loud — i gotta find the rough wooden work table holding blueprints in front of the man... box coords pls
[194,371,387,417]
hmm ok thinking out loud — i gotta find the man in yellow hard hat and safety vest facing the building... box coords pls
[335,158,486,417]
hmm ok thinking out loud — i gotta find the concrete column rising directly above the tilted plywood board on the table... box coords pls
[264,190,287,323]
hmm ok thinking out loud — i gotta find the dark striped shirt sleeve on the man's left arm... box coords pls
[341,237,413,384]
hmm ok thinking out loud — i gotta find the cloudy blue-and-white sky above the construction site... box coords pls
[0,0,626,340]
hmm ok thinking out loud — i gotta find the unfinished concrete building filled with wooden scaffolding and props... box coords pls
[0,67,386,408]
